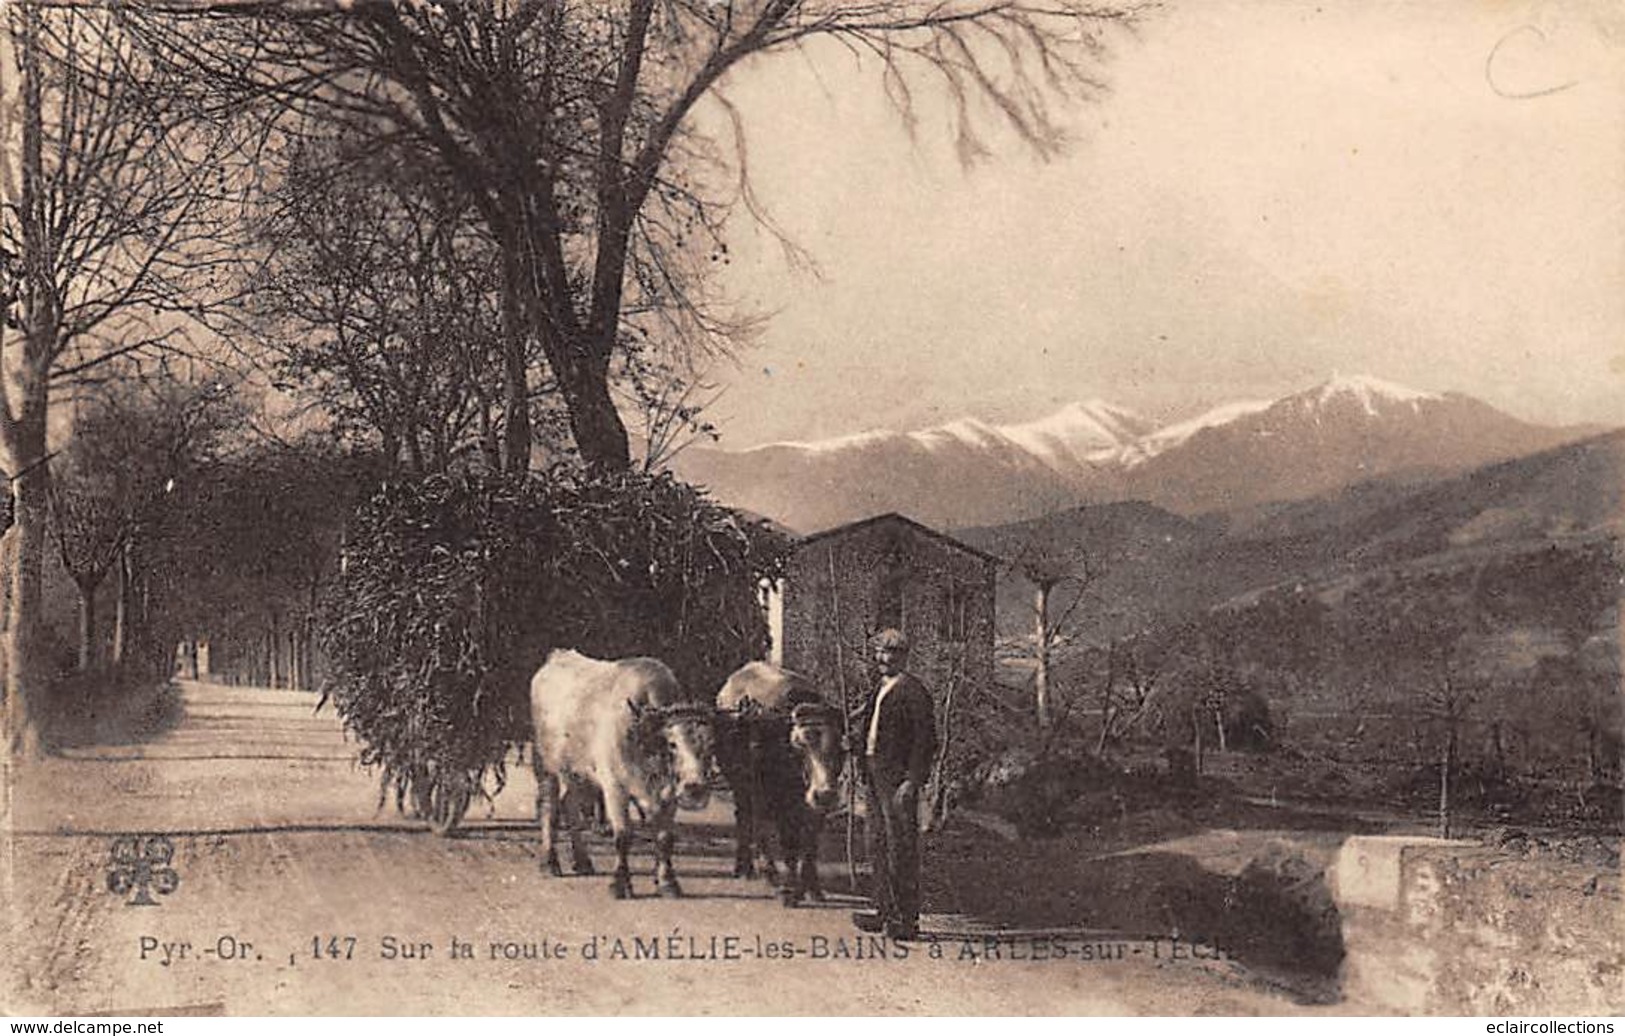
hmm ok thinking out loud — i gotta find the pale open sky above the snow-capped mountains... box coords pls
[685,0,1625,448]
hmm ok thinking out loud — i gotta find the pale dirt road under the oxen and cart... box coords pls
[0,684,1300,1015]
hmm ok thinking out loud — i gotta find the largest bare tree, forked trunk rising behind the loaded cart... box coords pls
[136,0,1131,469]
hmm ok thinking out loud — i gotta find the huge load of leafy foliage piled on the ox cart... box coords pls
[322,468,787,823]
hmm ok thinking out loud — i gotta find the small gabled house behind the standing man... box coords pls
[767,515,998,724]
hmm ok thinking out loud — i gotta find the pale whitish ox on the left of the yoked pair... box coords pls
[530,651,715,900]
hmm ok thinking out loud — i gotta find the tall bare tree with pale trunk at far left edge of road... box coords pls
[0,3,240,755]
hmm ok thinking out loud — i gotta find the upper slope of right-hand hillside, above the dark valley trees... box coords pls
[962,432,1625,665]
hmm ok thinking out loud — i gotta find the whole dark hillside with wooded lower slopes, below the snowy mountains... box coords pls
[967,432,1625,808]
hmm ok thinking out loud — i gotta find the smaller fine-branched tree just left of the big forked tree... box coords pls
[249,140,513,476]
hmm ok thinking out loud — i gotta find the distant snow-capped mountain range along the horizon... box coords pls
[676,377,1589,531]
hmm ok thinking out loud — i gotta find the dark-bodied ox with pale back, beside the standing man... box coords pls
[717,663,845,906]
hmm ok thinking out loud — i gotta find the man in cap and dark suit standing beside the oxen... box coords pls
[852,630,936,939]
